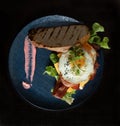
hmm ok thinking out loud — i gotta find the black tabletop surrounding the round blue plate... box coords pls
[0,0,120,126]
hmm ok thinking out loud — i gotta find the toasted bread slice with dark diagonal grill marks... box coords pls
[28,24,89,52]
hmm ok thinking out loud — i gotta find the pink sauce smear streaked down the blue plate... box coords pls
[22,36,36,89]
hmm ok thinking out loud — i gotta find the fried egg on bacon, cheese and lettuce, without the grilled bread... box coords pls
[45,43,99,104]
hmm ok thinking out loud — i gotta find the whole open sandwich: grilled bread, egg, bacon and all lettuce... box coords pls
[28,23,109,104]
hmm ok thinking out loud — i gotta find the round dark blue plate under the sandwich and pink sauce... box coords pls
[9,15,103,111]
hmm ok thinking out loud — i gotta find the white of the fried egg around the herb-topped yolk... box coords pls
[59,47,96,84]
